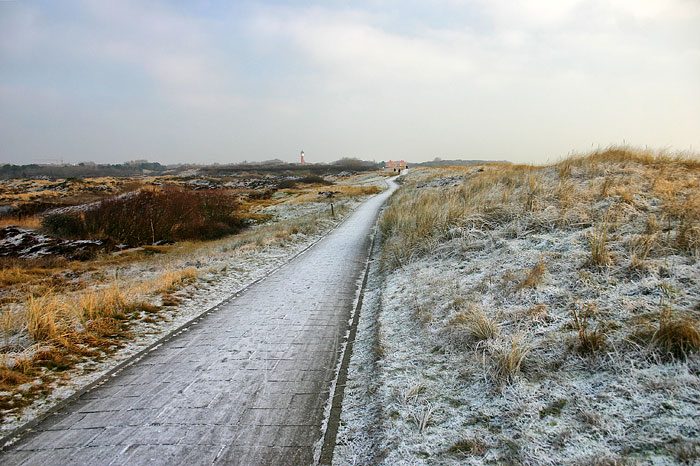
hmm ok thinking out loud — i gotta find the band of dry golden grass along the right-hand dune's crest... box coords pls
[380,149,700,270]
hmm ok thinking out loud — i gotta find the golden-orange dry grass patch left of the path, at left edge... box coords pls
[0,269,186,416]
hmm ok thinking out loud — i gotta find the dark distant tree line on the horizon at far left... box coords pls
[0,160,167,179]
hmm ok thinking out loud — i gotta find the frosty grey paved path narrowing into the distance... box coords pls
[0,177,395,466]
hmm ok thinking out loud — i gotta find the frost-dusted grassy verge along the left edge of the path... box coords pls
[0,188,378,435]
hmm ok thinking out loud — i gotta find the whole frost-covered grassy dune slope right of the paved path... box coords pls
[334,151,700,465]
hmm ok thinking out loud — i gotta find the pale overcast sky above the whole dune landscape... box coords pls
[0,0,700,163]
